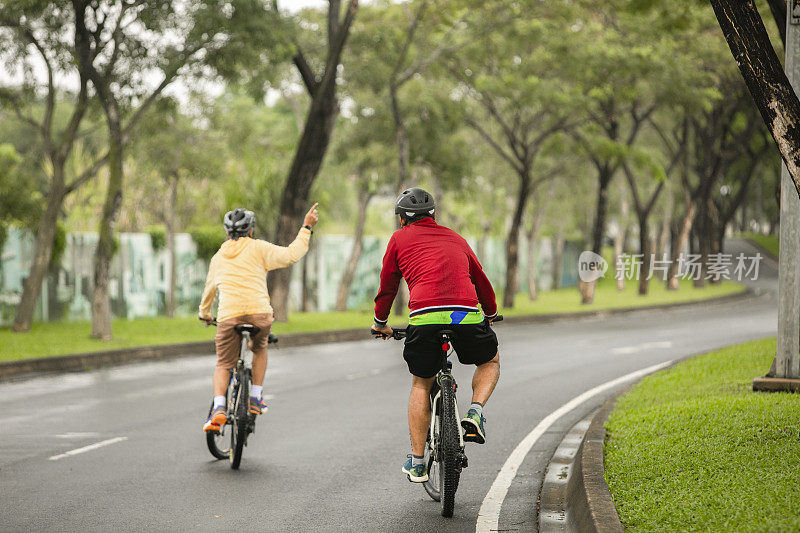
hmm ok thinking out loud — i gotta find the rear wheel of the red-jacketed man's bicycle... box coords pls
[439,377,461,517]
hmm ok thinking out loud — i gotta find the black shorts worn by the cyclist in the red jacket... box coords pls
[403,320,497,378]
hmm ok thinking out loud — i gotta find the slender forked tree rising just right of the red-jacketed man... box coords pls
[447,1,575,307]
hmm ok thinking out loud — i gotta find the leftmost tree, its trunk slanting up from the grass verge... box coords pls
[0,1,105,332]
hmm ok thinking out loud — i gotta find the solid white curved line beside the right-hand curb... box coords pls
[475,361,672,533]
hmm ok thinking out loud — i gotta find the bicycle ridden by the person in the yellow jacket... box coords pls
[201,319,278,470]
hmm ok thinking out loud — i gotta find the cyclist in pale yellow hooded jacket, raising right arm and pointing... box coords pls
[199,204,319,431]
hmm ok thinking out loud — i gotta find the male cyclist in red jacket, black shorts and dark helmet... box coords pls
[372,187,500,483]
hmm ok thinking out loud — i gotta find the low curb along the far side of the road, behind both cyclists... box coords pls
[0,289,754,380]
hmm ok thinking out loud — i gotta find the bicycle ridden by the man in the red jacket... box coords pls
[371,315,503,518]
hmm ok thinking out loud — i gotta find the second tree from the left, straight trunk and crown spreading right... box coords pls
[72,0,277,340]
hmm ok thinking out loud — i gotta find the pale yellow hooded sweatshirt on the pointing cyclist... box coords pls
[200,228,311,321]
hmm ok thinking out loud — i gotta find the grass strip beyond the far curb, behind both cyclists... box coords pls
[0,282,744,361]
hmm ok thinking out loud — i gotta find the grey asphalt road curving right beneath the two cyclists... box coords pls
[0,243,776,533]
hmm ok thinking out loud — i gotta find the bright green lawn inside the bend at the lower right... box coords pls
[605,339,800,532]
